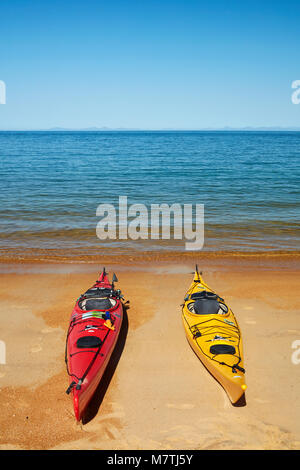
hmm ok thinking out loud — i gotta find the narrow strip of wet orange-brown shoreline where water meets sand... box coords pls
[0,251,300,274]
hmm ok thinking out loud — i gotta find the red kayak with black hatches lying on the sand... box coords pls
[65,268,123,421]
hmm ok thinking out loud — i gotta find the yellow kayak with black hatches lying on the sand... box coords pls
[182,266,247,403]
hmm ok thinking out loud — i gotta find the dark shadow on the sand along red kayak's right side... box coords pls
[82,304,129,424]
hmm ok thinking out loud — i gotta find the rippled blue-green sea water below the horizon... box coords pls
[0,132,300,253]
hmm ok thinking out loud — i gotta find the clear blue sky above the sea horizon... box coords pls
[0,0,300,129]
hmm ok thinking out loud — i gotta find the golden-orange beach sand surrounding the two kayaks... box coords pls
[0,258,300,449]
